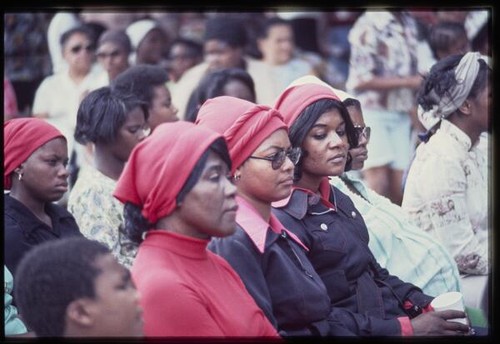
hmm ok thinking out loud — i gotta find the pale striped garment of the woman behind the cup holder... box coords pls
[330,173,460,296]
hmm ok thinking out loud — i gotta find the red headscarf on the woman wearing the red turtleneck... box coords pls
[113,121,221,224]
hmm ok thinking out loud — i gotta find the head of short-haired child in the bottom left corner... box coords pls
[14,237,142,337]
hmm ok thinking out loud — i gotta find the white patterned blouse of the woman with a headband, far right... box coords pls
[402,120,490,274]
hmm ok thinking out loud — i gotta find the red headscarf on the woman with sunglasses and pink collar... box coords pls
[196,96,288,173]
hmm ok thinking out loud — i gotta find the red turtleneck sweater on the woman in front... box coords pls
[132,230,278,337]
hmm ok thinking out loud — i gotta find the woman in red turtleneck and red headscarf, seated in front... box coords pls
[114,121,277,338]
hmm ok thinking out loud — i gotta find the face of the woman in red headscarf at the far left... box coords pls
[13,137,69,202]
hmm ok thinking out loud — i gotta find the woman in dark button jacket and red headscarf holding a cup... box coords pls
[273,84,469,336]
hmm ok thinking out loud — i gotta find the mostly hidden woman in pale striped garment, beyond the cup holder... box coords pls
[293,76,460,296]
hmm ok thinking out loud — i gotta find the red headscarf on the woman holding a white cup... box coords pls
[274,83,340,127]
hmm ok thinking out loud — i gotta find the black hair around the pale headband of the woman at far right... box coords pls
[417,54,491,111]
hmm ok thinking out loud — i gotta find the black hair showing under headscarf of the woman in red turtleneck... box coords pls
[119,138,231,244]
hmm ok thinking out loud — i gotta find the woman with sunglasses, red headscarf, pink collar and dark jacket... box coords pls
[197,96,352,337]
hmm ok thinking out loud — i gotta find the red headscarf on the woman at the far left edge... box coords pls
[3,117,66,190]
